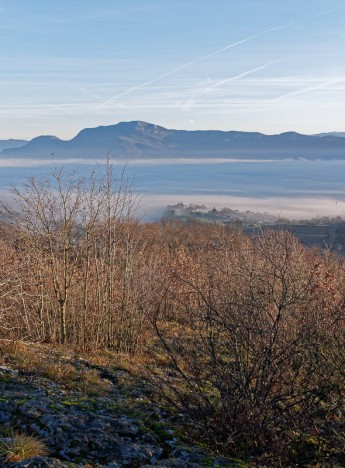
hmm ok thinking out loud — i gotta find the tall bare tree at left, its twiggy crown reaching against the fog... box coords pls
[1,160,136,343]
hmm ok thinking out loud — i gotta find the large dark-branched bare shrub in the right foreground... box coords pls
[149,228,345,462]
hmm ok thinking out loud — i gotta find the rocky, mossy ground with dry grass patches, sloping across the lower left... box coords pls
[0,345,238,468]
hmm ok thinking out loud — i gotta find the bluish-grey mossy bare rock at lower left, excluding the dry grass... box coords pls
[0,352,232,468]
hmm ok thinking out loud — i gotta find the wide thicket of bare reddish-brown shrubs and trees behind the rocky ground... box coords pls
[0,165,345,466]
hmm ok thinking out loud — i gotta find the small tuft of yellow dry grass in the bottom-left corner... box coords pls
[0,433,49,462]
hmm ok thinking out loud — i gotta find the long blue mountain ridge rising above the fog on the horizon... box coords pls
[0,121,345,160]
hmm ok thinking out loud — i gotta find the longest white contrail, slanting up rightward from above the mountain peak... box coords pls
[96,23,293,110]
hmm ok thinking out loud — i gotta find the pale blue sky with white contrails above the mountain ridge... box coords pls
[0,0,345,139]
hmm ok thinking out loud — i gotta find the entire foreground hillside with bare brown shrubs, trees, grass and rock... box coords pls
[0,165,345,467]
